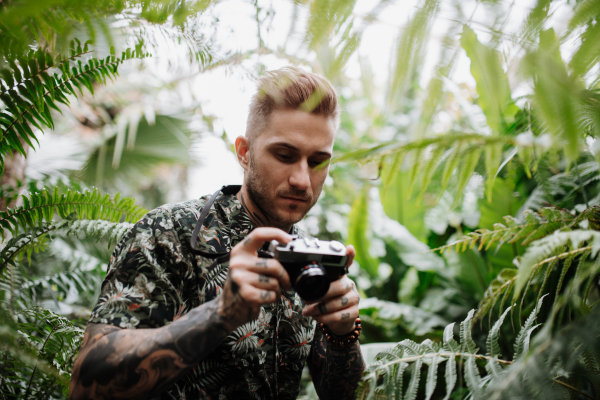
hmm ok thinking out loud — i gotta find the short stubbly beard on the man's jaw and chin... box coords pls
[246,153,320,230]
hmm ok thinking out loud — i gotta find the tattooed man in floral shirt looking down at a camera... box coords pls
[70,68,364,399]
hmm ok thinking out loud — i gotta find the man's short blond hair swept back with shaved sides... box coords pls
[246,67,340,143]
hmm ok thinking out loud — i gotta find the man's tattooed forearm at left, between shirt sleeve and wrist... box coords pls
[70,299,230,399]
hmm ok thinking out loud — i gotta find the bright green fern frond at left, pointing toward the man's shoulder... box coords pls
[0,187,146,239]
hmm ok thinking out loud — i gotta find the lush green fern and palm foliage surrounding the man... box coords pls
[0,0,600,398]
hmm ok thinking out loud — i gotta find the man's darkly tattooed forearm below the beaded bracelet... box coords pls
[307,341,365,400]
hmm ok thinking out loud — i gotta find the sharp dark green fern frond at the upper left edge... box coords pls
[0,40,149,168]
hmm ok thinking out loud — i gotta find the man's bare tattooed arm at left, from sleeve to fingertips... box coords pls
[70,228,291,399]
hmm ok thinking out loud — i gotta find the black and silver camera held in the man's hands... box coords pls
[269,236,348,302]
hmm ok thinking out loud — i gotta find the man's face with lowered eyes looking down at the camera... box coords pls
[244,110,335,229]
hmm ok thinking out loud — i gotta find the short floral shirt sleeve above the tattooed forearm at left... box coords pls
[89,208,190,329]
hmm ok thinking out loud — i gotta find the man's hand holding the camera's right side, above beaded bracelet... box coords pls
[302,245,360,336]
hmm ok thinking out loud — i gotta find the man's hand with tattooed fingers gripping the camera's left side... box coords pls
[217,228,292,330]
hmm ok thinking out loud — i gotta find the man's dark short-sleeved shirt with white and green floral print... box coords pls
[89,189,316,400]
